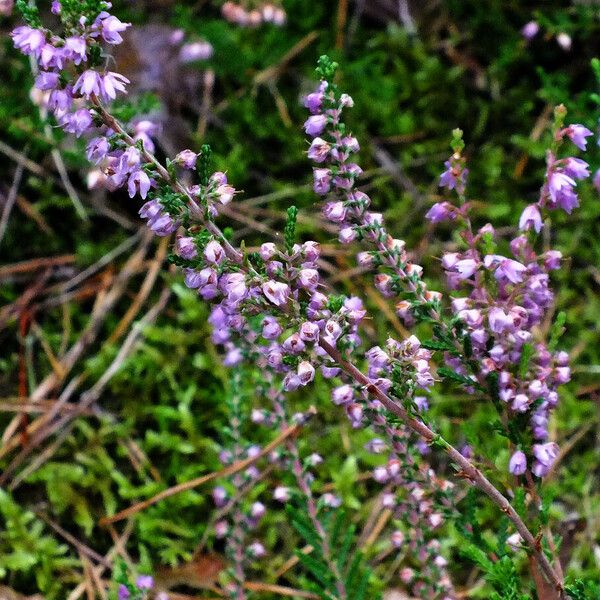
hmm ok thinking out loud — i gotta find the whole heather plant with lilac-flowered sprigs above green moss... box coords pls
[4,3,591,598]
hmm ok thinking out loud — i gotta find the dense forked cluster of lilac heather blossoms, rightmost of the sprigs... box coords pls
[428,125,591,477]
